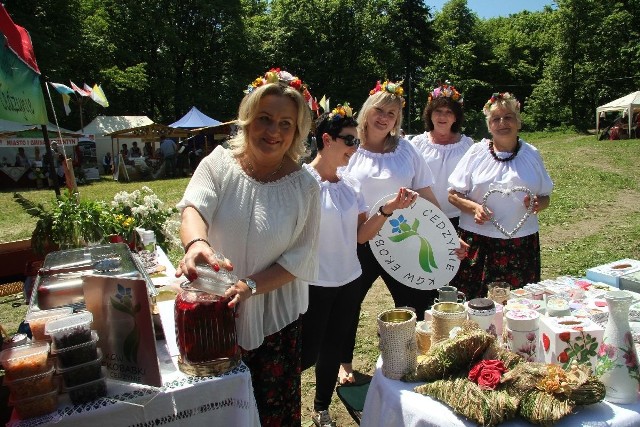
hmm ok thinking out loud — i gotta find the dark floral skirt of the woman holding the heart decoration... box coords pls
[451,229,541,300]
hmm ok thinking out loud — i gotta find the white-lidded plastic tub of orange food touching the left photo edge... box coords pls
[0,341,49,381]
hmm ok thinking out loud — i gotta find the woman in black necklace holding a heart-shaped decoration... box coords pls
[449,92,553,299]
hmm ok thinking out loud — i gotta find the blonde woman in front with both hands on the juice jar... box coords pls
[176,70,320,426]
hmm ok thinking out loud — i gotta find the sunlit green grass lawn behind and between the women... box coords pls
[0,132,640,426]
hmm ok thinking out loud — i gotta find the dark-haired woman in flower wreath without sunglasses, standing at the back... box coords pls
[411,83,473,229]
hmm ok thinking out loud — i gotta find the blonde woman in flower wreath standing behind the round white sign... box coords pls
[338,81,464,384]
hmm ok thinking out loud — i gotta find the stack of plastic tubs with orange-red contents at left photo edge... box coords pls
[0,342,58,419]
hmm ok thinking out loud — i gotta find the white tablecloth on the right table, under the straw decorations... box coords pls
[360,358,640,427]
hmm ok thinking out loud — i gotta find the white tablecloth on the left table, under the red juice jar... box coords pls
[7,247,260,427]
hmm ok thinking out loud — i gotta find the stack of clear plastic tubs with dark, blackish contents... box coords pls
[45,311,107,404]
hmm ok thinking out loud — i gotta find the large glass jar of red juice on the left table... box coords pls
[175,266,240,376]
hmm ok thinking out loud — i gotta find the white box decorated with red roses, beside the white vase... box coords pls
[540,316,604,372]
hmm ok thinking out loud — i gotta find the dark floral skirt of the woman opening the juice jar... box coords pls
[242,318,302,427]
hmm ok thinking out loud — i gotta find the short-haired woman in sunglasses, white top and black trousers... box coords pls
[302,103,411,426]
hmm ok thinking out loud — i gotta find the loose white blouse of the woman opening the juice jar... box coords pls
[177,147,320,350]
